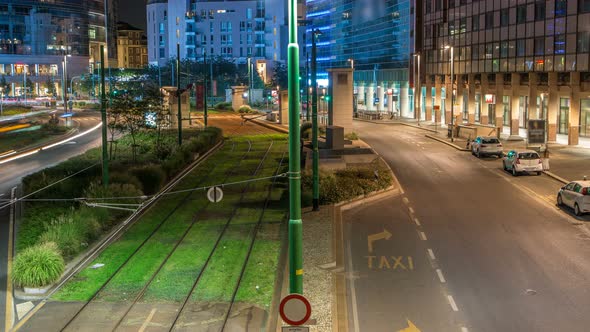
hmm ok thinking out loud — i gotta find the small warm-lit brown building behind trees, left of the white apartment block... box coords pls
[117,22,148,68]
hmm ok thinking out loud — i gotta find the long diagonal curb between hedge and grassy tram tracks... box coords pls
[15,140,224,304]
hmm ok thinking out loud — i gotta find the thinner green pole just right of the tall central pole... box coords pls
[311,30,320,211]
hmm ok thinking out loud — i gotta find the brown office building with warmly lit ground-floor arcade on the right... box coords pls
[416,0,590,145]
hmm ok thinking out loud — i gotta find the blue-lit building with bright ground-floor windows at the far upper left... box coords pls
[0,0,117,96]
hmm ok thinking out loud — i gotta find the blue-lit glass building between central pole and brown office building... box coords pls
[306,0,414,116]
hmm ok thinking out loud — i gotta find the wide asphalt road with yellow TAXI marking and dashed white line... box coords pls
[350,122,590,332]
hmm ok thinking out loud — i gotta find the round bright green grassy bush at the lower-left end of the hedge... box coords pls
[12,242,65,287]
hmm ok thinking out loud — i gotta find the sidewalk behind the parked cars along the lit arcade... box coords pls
[355,118,590,183]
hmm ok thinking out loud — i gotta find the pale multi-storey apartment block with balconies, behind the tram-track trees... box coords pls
[147,0,287,71]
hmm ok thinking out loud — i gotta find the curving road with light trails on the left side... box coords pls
[0,112,101,331]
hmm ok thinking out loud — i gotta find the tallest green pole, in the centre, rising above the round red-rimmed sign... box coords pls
[288,0,303,294]
